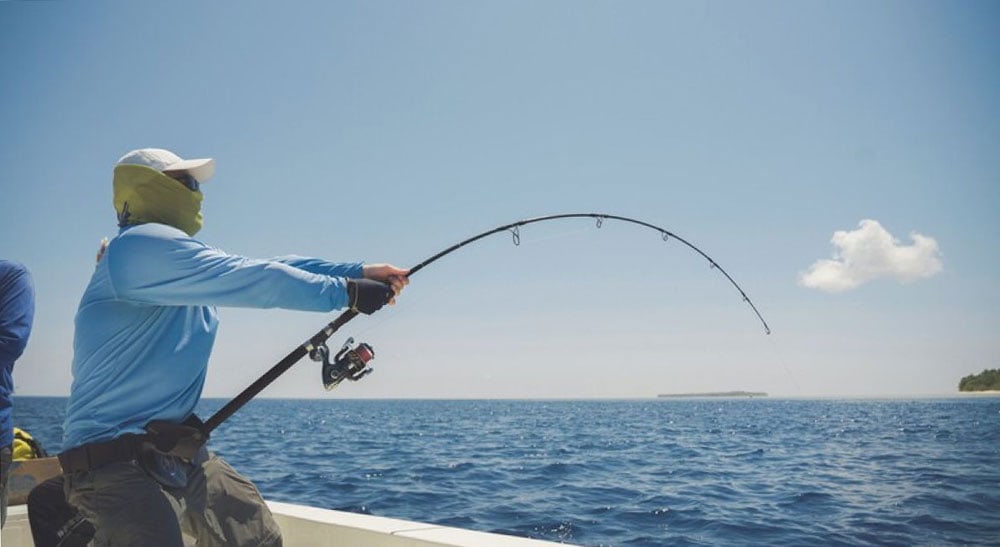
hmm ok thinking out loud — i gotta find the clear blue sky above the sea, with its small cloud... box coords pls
[0,0,1000,398]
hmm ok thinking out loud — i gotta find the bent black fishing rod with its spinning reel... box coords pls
[202,213,771,436]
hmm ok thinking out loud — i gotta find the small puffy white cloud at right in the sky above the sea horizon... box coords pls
[799,219,943,292]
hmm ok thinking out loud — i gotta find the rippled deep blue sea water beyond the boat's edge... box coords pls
[14,397,1000,546]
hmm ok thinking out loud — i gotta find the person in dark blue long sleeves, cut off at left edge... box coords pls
[0,260,35,527]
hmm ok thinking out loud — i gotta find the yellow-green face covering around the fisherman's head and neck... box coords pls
[114,164,204,236]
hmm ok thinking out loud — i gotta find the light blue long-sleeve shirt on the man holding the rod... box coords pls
[63,223,362,450]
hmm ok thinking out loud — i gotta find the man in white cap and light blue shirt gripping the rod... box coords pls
[59,148,408,547]
